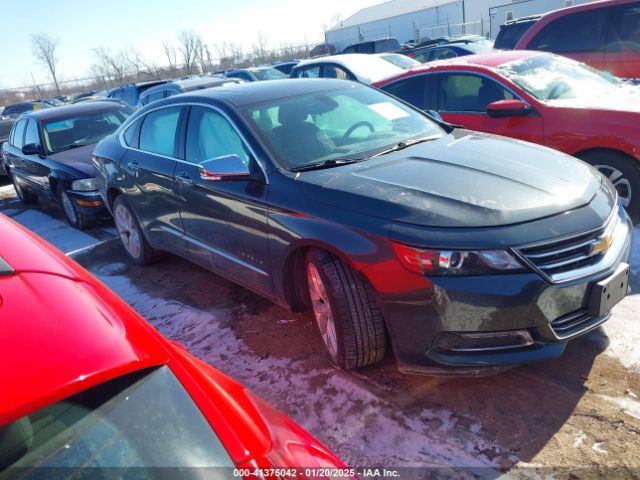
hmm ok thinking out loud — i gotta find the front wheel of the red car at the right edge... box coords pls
[579,151,640,222]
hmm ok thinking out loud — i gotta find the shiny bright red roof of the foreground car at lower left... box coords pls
[0,215,168,425]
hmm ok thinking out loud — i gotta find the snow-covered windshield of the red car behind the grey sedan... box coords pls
[499,55,622,102]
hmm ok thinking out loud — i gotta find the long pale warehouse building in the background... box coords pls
[325,0,593,51]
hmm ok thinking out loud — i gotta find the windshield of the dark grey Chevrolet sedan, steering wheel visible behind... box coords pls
[246,84,445,169]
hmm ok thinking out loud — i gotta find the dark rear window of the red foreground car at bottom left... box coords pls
[0,366,233,479]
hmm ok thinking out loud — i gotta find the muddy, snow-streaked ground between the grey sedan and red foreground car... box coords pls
[0,181,640,478]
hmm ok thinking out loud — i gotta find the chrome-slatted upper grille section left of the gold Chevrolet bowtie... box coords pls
[520,229,604,278]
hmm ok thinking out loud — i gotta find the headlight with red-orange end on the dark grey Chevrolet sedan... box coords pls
[392,242,525,276]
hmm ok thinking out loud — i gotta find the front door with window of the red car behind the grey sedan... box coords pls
[434,72,544,144]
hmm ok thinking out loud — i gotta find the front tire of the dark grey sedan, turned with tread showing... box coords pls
[305,249,386,370]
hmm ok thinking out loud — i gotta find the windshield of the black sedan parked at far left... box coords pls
[43,108,129,153]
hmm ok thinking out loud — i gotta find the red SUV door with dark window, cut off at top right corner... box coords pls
[603,2,640,78]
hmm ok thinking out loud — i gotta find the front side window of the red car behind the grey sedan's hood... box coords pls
[438,74,514,113]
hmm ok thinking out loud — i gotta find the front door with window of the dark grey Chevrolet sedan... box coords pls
[176,106,271,292]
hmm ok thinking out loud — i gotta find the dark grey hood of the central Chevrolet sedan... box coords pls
[297,130,602,227]
